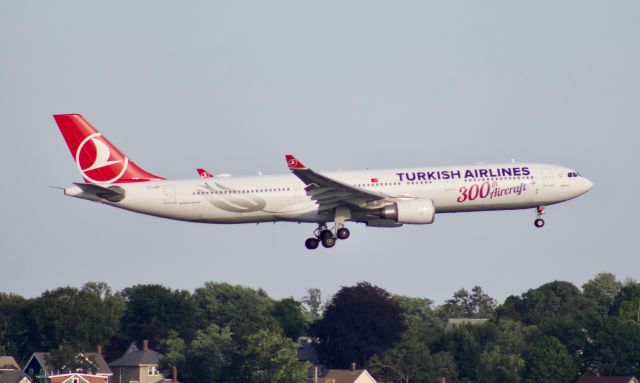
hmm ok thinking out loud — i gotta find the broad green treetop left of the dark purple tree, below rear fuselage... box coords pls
[193,282,280,338]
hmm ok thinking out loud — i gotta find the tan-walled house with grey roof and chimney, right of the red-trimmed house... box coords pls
[109,340,165,383]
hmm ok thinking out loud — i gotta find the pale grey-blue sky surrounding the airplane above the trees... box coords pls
[0,1,640,303]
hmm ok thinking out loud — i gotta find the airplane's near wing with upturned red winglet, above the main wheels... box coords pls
[285,154,391,210]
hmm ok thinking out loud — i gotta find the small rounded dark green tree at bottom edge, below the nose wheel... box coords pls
[524,336,578,383]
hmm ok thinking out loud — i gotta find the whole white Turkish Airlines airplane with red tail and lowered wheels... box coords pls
[53,114,593,249]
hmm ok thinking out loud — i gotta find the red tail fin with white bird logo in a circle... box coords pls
[53,114,164,184]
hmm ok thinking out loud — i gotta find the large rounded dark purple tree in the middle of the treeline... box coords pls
[310,282,406,368]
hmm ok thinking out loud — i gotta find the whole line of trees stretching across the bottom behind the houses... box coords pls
[0,273,640,383]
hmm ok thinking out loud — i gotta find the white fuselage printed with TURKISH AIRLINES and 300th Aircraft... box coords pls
[65,163,592,223]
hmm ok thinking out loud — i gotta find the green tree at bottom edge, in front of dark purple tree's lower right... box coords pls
[367,330,436,383]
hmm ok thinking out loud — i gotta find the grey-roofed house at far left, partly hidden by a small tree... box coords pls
[22,347,113,383]
